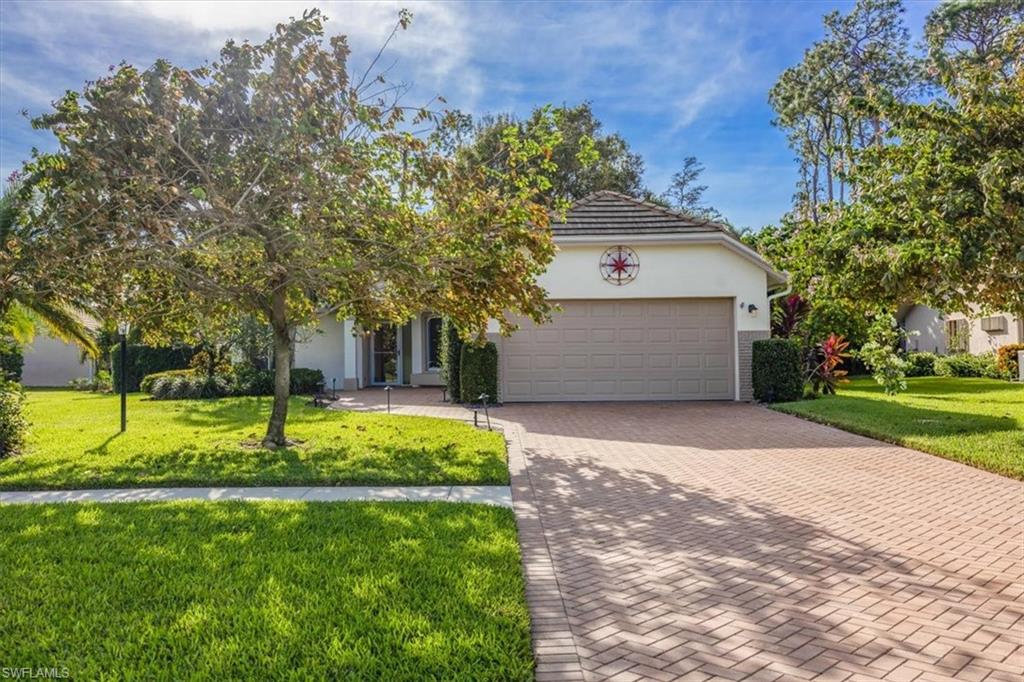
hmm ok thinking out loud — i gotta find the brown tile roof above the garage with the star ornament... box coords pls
[551,189,728,237]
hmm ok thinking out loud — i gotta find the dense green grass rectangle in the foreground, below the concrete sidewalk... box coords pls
[0,502,532,680]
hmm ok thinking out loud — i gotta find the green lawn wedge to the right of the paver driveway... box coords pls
[771,377,1024,479]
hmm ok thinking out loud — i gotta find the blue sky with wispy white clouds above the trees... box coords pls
[0,0,934,228]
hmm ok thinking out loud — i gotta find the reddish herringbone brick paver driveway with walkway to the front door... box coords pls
[339,390,1024,682]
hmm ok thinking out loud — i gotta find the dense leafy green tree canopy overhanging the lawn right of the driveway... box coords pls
[803,3,1024,314]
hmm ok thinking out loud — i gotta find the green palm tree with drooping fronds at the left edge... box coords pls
[0,182,99,357]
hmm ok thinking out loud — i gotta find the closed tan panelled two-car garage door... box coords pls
[501,298,735,402]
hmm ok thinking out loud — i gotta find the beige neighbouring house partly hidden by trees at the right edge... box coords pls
[896,304,1024,355]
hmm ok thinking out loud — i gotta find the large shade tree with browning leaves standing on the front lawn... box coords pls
[28,10,558,446]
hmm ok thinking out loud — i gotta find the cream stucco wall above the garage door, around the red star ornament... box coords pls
[540,242,771,332]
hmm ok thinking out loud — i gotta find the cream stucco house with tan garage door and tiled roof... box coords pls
[295,191,785,402]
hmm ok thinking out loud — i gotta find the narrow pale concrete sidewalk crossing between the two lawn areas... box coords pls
[0,485,512,507]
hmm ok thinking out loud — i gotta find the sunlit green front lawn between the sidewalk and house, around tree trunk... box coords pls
[0,390,509,489]
